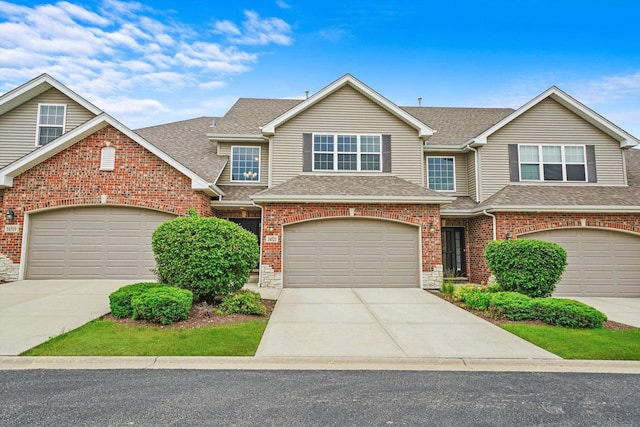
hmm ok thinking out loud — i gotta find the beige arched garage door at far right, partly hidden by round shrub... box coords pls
[522,228,640,297]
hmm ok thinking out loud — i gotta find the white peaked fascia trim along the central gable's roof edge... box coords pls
[261,74,435,140]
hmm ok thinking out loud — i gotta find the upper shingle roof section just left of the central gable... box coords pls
[209,98,302,135]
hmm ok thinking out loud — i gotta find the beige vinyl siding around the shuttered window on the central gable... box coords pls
[272,86,424,185]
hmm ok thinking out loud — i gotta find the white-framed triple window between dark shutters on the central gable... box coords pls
[313,134,382,172]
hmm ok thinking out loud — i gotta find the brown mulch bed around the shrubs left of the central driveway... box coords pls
[101,299,276,329]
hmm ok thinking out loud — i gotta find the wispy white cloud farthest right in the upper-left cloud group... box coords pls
[214,10,293,46]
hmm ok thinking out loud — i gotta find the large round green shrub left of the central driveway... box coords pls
[151,214,260,299]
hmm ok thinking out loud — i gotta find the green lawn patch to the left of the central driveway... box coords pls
[22,320,267,356]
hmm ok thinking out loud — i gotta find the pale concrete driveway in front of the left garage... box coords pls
[0,280,134,356]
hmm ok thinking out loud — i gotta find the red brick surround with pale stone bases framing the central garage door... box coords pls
[260,203,442,288]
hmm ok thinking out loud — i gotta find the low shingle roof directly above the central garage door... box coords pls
[254,175,453,201]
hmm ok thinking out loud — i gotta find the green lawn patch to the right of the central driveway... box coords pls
[501,324,640,360]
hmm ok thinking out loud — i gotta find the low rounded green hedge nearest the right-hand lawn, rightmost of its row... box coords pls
[533,298,607,328]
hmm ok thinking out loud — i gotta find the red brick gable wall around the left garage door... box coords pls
[0,126,212,279]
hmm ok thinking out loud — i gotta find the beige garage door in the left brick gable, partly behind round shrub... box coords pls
[25,206,175,279]
